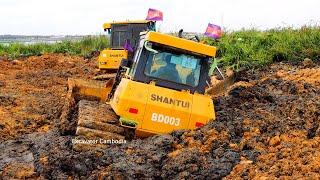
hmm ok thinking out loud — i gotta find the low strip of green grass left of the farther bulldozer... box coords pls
[0,35,109,59]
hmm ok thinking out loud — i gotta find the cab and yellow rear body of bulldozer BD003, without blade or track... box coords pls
[108,31,216,137]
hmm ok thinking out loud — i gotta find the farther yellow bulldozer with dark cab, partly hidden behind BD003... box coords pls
[98,20,155,71]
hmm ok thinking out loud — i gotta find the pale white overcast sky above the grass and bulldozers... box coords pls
[0,0,320,35]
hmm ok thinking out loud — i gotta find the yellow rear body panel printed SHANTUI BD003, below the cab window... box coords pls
[110,78,215,136]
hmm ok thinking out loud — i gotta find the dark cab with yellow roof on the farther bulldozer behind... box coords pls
[103,20,155,49]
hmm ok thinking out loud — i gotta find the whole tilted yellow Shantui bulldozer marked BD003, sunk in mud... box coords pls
[60,29,232,150]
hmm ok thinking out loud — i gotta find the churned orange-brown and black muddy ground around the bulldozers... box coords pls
[0,54,320,179]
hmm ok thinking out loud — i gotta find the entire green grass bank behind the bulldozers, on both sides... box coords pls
[0,26,320,69]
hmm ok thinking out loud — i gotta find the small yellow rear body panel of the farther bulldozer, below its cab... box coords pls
[98,49,128,69]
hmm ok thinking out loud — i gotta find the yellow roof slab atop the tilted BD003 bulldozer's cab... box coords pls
[146,31,217,57]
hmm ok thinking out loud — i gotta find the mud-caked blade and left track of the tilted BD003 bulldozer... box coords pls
[59,79,126,150]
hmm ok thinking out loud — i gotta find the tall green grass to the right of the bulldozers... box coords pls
[206,26,320,69]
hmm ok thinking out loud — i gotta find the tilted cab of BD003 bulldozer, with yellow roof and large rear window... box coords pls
[128,32,216,94]
